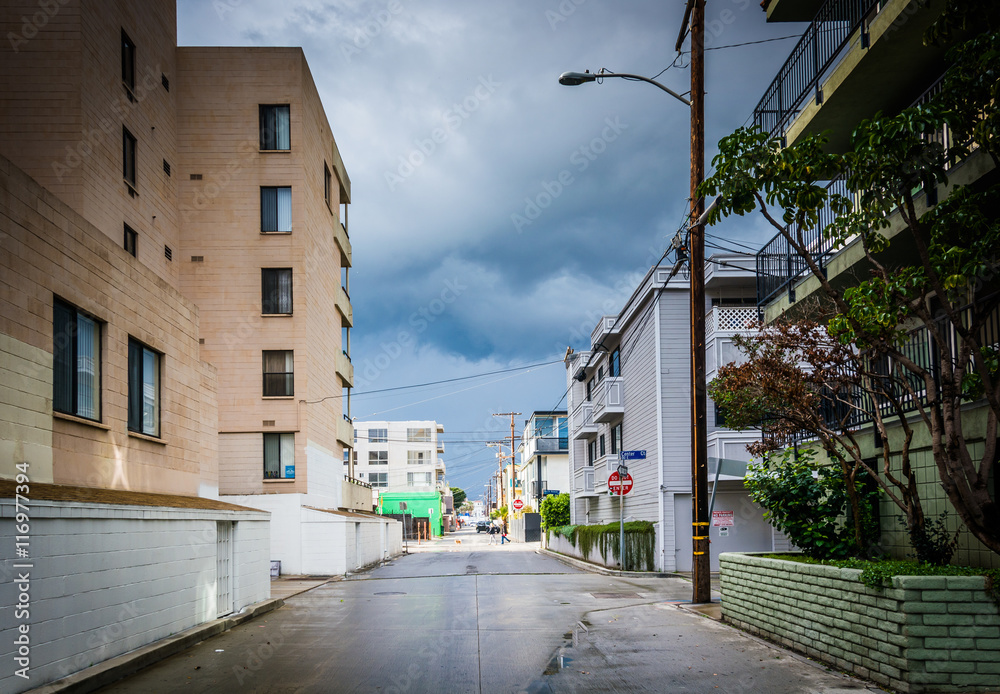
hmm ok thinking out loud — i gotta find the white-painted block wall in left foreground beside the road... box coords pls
[0,499,270,693]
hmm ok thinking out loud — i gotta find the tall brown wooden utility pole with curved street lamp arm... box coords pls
[559,0,712,603]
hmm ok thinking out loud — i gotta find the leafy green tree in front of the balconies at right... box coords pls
[700,27,1000,556]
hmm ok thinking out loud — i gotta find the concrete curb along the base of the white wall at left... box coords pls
[25,598,285,694]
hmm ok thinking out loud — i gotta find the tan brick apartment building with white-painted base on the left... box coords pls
[0,0,399,691]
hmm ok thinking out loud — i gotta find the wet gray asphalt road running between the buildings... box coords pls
[92,530,876,694]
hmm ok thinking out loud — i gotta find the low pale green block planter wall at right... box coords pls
[720,553,1000,692]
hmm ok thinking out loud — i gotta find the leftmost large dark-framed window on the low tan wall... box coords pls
[52,300,101,421]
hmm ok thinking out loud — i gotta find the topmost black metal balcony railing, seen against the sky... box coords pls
[753,0,884,135]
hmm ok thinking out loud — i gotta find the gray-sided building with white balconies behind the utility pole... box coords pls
[566,254,787,571]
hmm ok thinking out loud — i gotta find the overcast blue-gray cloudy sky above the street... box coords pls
[178,0,801,498]
